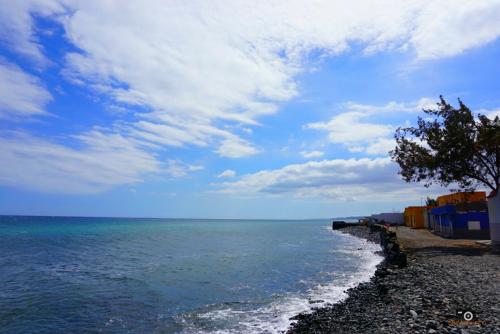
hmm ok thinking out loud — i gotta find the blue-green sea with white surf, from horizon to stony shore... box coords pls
[0,216,380,334]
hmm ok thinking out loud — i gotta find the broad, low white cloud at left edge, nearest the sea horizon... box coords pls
[0,131,161,193]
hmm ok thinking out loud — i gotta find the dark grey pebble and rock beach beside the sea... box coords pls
[287,226,500,334]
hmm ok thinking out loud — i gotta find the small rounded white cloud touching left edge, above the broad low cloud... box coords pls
[0,58,52,119]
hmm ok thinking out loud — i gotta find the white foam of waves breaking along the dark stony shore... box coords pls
[184,230,382,334]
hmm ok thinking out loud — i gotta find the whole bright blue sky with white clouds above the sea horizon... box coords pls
[0,0,500,219]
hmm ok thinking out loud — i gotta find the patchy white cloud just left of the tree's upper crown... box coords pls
[304,98,436,155]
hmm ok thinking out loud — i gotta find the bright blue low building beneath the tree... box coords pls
[431,201,490,239]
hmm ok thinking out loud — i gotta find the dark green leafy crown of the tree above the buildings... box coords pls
[390,96,500,191]
